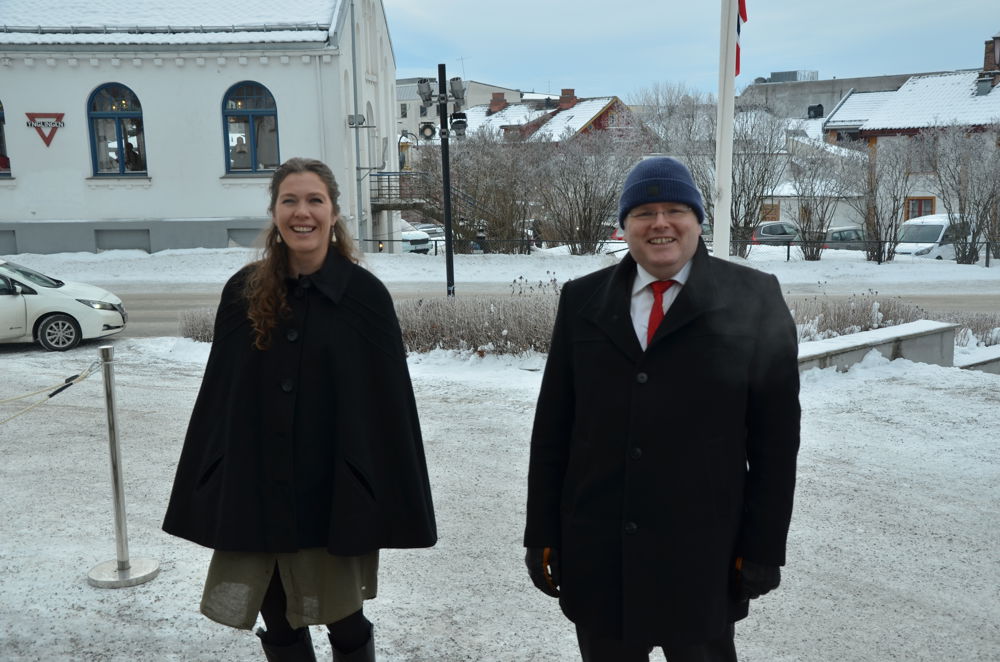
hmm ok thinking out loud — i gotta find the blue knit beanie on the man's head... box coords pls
[618,156,705,228]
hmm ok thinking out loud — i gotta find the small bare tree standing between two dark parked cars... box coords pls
[788,139,858,261]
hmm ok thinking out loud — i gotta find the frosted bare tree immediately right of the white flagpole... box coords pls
[730,104,788,257]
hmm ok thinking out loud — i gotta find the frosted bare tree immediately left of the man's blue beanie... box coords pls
[537,132,645,255]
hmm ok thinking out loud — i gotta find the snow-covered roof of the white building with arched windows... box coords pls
[0,0,341,48]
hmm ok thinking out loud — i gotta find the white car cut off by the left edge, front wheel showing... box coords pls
[0,259,128,352]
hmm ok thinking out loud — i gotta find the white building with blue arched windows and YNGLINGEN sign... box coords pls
[0,0,398,254]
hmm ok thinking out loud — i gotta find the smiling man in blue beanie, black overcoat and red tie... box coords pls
[524,157,799,662]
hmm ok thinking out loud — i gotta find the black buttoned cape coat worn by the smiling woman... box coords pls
[163,251,437,555]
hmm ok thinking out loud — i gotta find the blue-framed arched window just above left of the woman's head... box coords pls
[222,80,281,173]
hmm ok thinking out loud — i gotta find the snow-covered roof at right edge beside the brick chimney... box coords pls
[861,71,1000,131]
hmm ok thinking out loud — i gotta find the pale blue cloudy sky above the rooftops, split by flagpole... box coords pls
[383,0,1000,100]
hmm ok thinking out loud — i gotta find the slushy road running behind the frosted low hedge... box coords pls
[118,283,1000,338]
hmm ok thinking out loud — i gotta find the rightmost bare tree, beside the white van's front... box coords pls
[918,125,1000,264]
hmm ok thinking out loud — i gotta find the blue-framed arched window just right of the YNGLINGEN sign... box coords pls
[87,83,146,176]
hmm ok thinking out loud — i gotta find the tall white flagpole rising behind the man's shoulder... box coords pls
[712,0,738,260]
